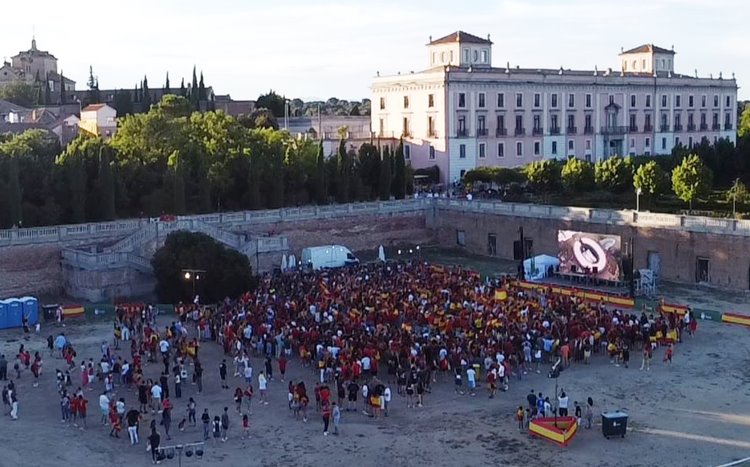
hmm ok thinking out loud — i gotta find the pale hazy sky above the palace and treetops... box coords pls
[0,0,750,100]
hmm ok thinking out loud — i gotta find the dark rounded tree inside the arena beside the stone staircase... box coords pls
[151,231,255,303]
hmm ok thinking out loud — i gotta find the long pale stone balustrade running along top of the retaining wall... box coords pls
[0,198,750,252]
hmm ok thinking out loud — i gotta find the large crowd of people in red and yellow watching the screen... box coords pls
[0,262,696,462]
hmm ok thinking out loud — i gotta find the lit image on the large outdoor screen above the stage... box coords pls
[557,230,621,281]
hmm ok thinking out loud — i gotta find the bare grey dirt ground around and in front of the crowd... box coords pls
[0,310,750,467]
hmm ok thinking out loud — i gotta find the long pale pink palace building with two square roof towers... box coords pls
[371,31,737,182]
